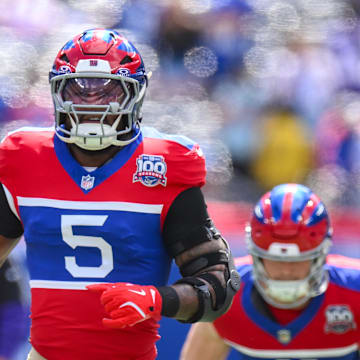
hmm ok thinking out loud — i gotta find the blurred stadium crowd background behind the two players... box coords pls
[0,0,360,360]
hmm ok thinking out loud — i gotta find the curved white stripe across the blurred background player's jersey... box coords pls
[224,339,358,359]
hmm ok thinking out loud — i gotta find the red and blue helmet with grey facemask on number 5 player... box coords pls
[49,29,148,150]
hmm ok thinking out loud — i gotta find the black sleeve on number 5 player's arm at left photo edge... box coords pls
[0,183,24,239]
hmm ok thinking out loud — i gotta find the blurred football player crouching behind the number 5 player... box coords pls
[181,184,360,360]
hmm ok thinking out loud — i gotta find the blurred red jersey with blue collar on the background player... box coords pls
[214,255,360,360]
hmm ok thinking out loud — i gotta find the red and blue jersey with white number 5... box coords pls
[0,128,205,360]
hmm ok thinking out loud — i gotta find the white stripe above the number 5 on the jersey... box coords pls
[17,196,163,214]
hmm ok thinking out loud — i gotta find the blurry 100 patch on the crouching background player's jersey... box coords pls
[325,305,356,334]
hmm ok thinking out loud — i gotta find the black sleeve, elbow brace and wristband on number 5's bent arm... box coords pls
[158,187,240,323]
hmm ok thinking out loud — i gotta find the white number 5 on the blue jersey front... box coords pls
[61,215,114,278]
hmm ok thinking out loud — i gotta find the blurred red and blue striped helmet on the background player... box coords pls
[246,184,331,308]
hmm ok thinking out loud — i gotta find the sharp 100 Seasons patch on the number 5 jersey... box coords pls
[133,154,167,187]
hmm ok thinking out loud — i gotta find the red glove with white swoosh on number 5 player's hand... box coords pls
[87,283,162,329]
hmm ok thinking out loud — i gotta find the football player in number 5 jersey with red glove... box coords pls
[0,29,239,360]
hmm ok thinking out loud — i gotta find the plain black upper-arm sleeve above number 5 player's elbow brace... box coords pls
[163,187,209,256]
